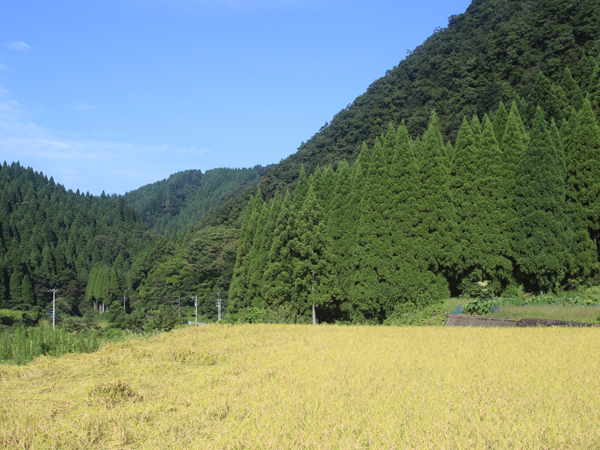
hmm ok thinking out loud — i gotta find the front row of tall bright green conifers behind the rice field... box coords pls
[229,64,600,322]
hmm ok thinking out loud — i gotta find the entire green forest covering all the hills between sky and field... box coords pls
[0,0,600,327]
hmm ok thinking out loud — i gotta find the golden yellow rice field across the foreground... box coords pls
[0,325,600,449]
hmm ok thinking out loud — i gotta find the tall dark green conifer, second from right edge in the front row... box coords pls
[513,108,571,290]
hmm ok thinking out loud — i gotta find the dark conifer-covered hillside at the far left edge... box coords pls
[0,162,153,311]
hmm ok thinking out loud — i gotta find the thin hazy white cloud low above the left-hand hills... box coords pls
[0,86,209,194]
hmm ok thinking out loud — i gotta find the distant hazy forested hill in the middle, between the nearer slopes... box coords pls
[125,166,265,234]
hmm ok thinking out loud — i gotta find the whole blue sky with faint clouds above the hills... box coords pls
[0,0,470,194]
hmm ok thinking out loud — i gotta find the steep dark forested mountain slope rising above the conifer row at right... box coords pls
[261,0,600,193]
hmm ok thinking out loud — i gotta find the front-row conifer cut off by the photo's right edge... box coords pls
[566,99,600,276]
